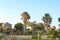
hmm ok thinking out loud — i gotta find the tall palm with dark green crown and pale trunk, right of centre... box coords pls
[42,13,52,30]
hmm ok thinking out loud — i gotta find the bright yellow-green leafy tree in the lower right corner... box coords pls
[47,28,60,40]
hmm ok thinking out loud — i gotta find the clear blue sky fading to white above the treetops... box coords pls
[0,0,60,27]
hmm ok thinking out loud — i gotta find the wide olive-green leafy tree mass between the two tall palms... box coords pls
[27,21,44,32]
